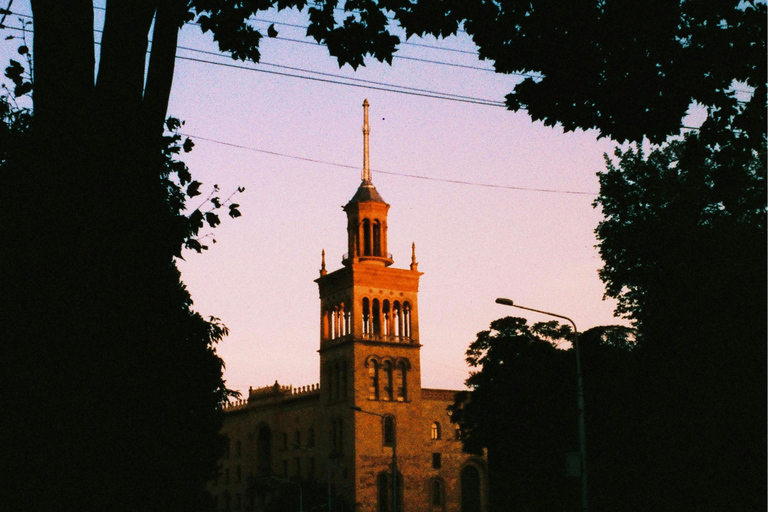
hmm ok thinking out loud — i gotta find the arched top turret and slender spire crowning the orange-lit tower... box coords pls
[342,100,394,267]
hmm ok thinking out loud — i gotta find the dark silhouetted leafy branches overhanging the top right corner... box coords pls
[392,0,766,142]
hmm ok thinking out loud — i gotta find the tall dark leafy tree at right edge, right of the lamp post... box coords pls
[596,135,768,511]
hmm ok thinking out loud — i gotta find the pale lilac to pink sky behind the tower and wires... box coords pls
[0,1,626,392]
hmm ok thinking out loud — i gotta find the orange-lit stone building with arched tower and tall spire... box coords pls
[209,100,487,512]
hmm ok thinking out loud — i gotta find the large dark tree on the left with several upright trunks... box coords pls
[0,0,404,511]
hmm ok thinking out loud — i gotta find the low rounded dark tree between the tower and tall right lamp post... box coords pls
[449,317,578,511]
